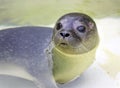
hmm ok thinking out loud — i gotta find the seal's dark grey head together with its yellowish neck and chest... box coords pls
[52,13,99,83]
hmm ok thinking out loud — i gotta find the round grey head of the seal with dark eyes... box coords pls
[53,13,98,54]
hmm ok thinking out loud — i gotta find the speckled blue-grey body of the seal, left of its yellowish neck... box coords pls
[0,26,57,88]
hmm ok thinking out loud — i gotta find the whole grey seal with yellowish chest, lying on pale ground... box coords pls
[0,13,99,88]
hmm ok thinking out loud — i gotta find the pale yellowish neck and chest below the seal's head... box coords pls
[53,46,97,83]
